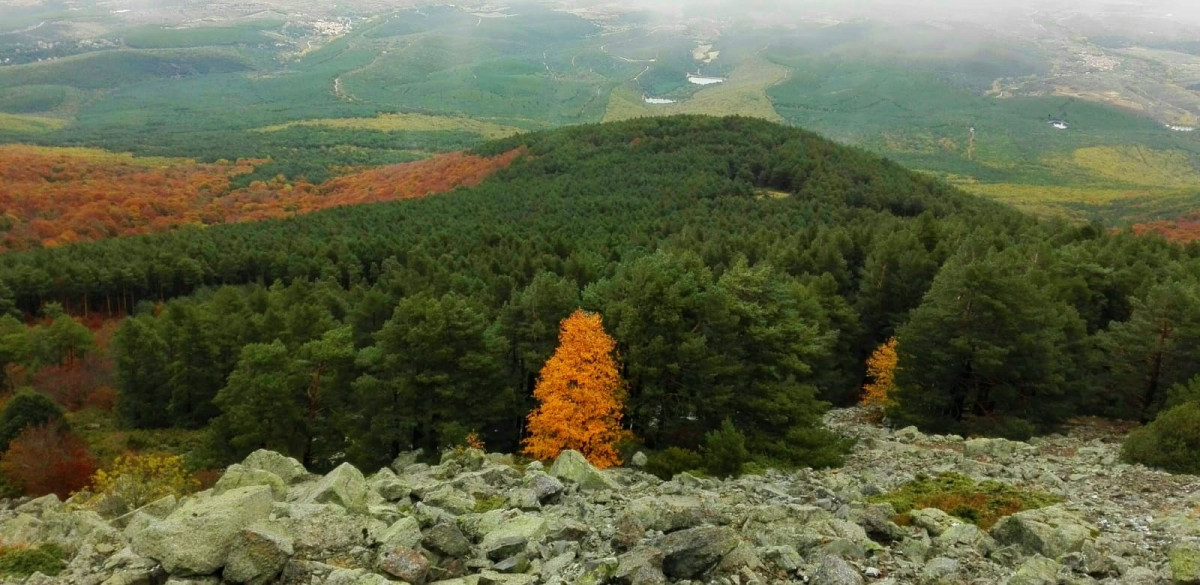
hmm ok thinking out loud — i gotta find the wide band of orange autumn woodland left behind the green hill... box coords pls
[0,145,521,252]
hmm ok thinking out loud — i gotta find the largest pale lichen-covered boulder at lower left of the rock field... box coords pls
[132,486,275,575]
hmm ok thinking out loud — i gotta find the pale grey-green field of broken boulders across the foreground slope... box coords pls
[7,410,1200,585]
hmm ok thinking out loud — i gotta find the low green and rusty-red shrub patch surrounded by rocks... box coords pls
[869,472,1062,530]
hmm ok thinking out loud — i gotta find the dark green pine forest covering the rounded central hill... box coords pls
[0,116,1200,484]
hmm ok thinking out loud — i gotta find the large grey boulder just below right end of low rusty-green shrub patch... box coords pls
[991,506,1098,560]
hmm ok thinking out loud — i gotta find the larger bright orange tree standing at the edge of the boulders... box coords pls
[524,309,625,469]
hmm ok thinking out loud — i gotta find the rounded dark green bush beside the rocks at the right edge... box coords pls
[1121,402,1200,474]
